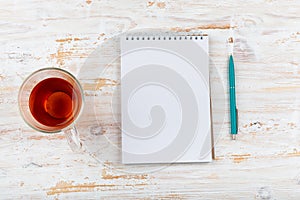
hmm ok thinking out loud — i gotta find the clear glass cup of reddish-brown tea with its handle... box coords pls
[18,68,84,151]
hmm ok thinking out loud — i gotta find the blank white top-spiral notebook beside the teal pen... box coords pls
[121,35,213,164]
